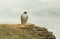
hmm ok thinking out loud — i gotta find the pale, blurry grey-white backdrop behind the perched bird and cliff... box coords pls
[0,0,60,39]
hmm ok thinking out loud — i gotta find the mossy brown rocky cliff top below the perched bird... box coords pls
[0,24,56,39]
